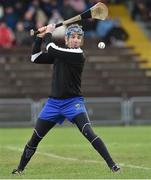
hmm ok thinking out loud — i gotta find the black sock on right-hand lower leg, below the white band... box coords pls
[92,137,115,168]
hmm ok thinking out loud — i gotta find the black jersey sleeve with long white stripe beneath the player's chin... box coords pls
[45,33,84,64]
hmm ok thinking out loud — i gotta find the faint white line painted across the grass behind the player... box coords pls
[3,146,151,171]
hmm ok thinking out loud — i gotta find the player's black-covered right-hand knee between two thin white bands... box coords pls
[81,124,97,142]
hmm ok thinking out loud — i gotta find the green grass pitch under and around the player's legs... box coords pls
[0,126,151,179]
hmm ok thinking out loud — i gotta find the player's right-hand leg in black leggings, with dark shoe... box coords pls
[73,113,120,172]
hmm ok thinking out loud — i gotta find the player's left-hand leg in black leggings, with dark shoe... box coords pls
[12,119,56,174]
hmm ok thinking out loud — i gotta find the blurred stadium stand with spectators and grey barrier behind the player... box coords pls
[0,0,151,126]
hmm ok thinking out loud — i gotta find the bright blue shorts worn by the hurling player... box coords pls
[39,97,87,124]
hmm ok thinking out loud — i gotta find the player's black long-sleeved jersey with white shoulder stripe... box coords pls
[31,33,85,98]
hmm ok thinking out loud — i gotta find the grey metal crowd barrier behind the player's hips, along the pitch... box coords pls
[0,97,151,127]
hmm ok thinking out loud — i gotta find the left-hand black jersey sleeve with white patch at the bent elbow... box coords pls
[31,37,54,64]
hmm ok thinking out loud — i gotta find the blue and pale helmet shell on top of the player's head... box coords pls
[65,24,84,38]
